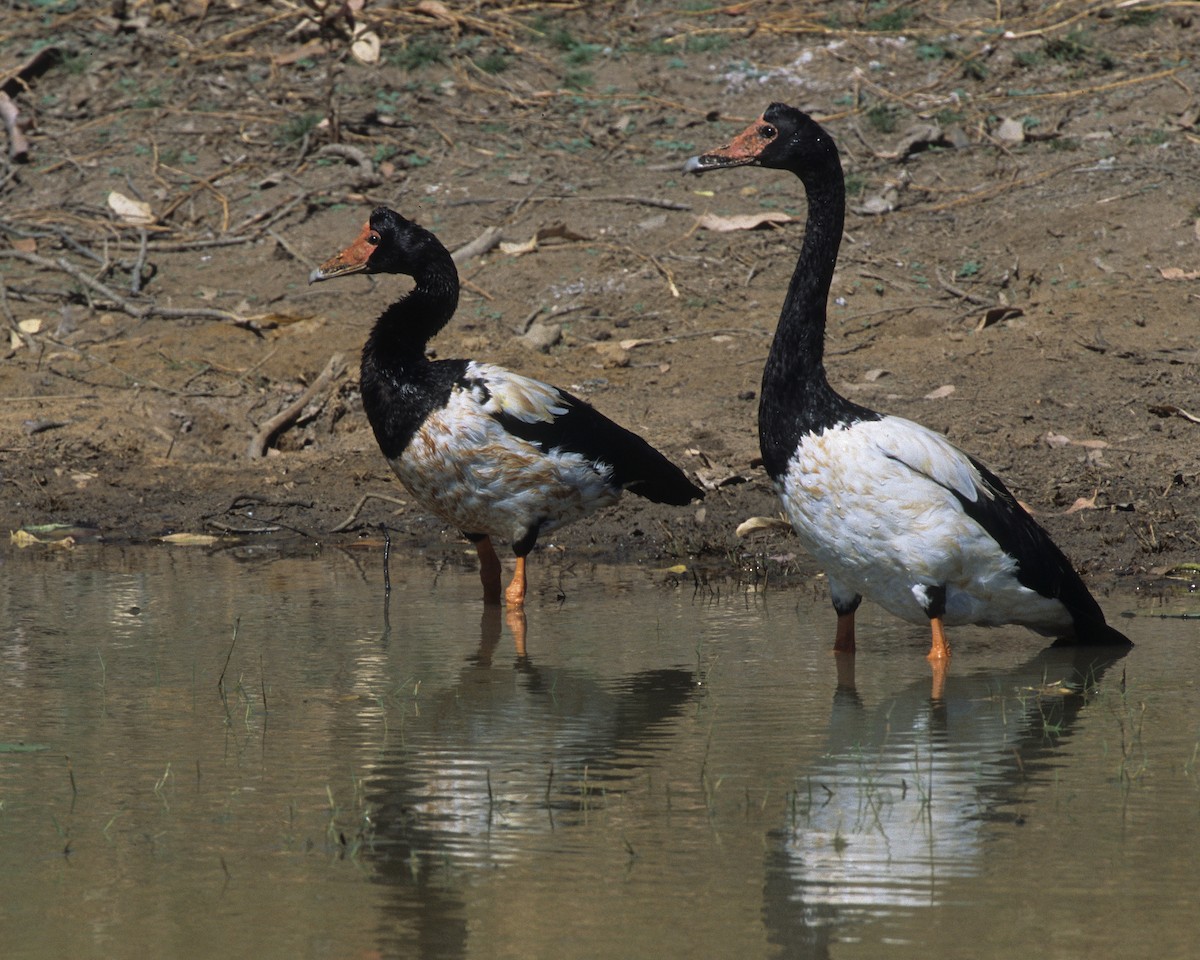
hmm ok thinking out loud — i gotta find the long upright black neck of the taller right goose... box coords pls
[758,132,875,478]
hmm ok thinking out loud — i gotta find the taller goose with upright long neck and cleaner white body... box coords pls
[685,103,1129,662]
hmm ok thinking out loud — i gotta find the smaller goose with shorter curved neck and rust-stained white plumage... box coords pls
[310,206,704,607]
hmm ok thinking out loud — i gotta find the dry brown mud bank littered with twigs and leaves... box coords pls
[0,0,1200,607]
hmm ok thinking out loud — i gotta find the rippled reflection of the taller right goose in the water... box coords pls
[763,647,1126,958]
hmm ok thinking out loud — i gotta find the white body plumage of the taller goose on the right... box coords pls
[776,416,1072,635]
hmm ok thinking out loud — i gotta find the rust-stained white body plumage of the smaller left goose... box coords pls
[390,361,620,541]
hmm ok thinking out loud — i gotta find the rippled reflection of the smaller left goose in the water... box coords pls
[362,607,697,958]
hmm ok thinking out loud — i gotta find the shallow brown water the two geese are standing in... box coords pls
[0,547,1200,958]
